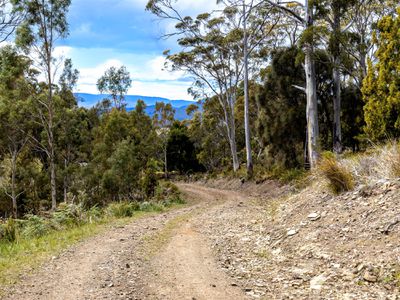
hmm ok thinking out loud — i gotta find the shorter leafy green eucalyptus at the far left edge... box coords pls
[0,46,35,218]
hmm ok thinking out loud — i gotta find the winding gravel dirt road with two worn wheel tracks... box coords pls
[4,184,246,300]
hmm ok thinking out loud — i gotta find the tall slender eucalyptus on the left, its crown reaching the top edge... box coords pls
[12,0,71,210]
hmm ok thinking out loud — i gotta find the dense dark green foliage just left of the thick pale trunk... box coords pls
[256,48,306,169]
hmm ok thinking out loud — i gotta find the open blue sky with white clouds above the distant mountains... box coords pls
[56,0,220,100]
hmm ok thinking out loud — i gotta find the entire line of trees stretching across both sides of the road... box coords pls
[0,0,400,217]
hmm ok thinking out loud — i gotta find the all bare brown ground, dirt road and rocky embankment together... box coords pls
[1,180,400,300]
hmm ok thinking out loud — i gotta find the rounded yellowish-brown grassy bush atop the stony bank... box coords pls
[319,156,354,194]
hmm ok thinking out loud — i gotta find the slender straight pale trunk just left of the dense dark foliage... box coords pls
[243,2,253,178]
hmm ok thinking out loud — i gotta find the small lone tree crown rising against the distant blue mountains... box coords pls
[97,66,132,110]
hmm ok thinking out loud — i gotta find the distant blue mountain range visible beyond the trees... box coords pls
[75,93,201,121]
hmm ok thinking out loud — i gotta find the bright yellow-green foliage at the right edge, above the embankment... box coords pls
[362,9,400,141]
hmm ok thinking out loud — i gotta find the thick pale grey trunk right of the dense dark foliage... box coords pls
[305,0,319,169]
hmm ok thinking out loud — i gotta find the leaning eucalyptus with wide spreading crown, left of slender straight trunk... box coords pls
[147,0,243,172]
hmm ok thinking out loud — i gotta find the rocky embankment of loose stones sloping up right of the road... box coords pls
[199,180,400,300]
